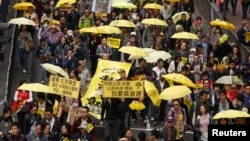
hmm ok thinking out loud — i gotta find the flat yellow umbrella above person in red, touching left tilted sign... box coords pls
[17,83,56,94]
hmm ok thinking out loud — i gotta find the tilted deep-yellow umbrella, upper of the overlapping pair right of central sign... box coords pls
[163,73,196,87]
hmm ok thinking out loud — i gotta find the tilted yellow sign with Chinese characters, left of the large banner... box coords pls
[49,75,80,98]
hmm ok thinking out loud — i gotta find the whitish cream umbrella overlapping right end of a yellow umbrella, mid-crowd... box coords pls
[144,51,172,63]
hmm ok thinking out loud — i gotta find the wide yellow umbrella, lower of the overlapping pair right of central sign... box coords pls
[159,86,192,100]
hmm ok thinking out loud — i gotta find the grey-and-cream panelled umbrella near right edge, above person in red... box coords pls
[215,75,244,85]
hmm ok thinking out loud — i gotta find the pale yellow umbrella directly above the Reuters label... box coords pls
[213,110,250,119]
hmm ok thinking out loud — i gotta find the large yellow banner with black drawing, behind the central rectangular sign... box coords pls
[81,59,131,102]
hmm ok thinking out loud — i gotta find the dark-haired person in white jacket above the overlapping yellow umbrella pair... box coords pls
[168,55,184,73]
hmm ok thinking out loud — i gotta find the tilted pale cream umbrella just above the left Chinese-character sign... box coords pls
[41,63,69,78]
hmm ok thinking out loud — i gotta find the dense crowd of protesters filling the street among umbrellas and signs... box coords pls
[0,0,250,141]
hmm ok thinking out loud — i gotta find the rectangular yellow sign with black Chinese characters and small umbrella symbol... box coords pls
[102,81,144,98]
